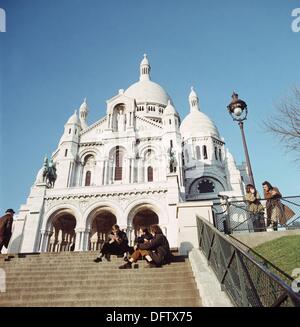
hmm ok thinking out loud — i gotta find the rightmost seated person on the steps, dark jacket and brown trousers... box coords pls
[119,225,171,269]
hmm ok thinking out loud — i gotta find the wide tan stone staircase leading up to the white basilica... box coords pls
[0,252,201,307]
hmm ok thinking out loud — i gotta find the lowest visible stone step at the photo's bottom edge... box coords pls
[1,297,201,307]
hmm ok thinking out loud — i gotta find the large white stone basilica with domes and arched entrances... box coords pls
[9,55,248,252]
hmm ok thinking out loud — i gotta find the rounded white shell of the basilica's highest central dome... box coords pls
[124,80,170,106]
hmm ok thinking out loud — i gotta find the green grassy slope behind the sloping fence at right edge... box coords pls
[254,235,300,275]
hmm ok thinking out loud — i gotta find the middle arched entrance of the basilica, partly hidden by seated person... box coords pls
[89,207,117,251]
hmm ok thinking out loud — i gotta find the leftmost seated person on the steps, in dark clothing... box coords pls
[94,225,129,262]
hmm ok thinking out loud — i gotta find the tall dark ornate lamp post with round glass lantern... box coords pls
[227,92,255,187]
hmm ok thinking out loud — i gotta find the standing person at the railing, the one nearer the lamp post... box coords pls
[245,184,266,232]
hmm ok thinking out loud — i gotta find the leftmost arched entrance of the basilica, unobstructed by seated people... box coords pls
[47,209,76,252]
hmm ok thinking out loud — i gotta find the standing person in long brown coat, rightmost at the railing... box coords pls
[262,181,295,231]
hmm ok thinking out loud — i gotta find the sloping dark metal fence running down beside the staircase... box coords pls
[197,217,300,307]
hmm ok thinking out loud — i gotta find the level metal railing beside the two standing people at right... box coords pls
[214,196,300,232]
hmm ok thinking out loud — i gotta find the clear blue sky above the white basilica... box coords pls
[0,0,300,212]
